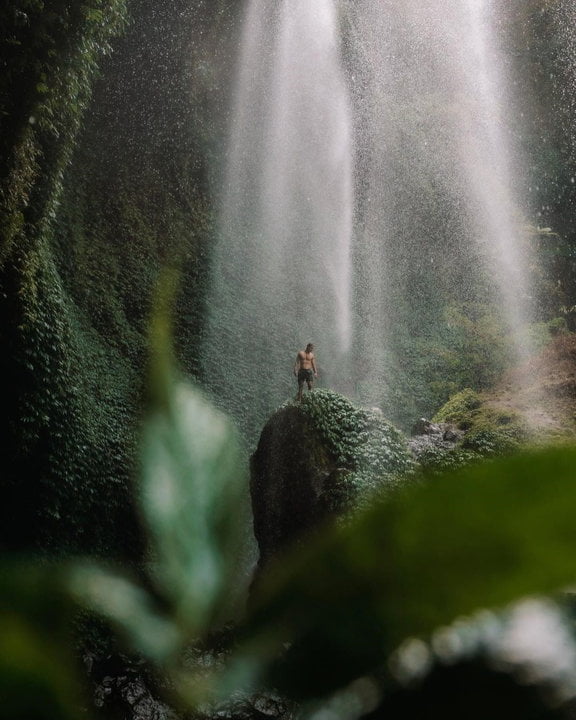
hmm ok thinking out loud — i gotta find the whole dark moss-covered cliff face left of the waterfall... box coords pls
[0,0,232,557]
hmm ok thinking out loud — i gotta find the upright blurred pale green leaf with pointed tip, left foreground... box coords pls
[141,275,247,635]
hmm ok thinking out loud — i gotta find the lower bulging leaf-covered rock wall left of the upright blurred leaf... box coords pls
[0,233,142,558]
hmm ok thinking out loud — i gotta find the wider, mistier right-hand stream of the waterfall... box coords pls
[345,0,529,414]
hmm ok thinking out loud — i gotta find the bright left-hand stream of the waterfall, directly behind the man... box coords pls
[204,0,353,438]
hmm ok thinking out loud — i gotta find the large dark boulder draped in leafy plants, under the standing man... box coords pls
[250,390,413,567]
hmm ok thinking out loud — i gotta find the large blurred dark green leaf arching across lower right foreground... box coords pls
[231,449,576,697]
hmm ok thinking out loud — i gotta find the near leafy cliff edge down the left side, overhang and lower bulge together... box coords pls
[0,0,139,555]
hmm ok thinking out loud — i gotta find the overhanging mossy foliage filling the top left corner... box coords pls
[0,0,126,262]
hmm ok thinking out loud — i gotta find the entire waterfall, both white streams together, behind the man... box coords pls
[204,0,528,442]
